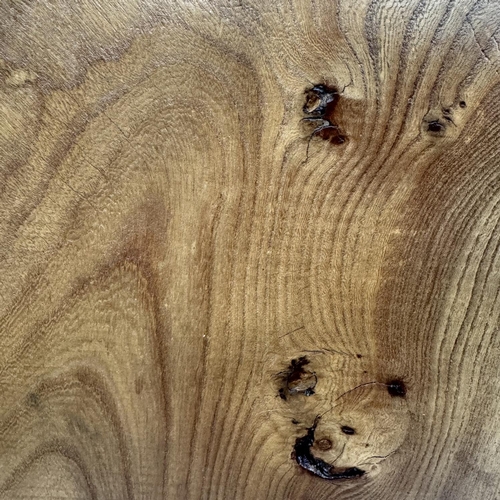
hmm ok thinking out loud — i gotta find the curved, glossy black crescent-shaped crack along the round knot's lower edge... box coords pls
[292,417,365,480]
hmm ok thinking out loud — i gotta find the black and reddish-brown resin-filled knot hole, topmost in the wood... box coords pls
[302,84,347,150]
